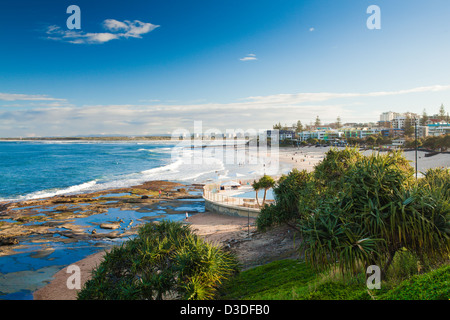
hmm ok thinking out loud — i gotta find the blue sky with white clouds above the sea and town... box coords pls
[0,0,450,137]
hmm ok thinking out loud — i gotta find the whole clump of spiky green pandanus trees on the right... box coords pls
[257,148,450,275]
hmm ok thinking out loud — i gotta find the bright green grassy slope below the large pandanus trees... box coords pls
[221,260,450,300]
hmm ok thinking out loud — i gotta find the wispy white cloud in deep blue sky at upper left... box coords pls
[46,19,159,44]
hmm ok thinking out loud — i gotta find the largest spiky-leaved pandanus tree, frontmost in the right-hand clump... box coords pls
[300,153,450,274]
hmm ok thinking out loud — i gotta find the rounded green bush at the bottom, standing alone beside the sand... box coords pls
[78,221,238,300]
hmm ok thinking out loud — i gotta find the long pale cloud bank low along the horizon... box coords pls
[0,85,450,136]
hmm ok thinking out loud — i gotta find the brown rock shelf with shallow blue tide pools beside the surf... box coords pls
[0,181,201,257]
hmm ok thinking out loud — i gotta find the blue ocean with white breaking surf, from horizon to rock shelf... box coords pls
[0,141,284,201]
